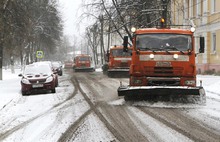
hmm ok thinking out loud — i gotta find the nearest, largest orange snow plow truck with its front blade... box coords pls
[118,25,206,103]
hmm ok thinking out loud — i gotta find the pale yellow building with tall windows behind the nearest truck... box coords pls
[171,0,220,73]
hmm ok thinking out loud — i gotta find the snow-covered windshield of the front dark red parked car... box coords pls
[24,64,52,75]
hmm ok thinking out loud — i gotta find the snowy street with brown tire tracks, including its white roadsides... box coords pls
[0,70,220,142]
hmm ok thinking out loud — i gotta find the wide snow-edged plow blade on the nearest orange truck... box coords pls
[118,86,205,96]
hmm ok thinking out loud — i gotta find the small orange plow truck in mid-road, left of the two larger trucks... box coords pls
[73,54,95,72]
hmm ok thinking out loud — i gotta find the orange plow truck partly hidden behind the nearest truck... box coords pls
[102,45,132,77]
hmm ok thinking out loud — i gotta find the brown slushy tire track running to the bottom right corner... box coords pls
[137,107,220,142]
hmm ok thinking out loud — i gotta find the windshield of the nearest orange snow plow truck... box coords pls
[136,33,192,51]
